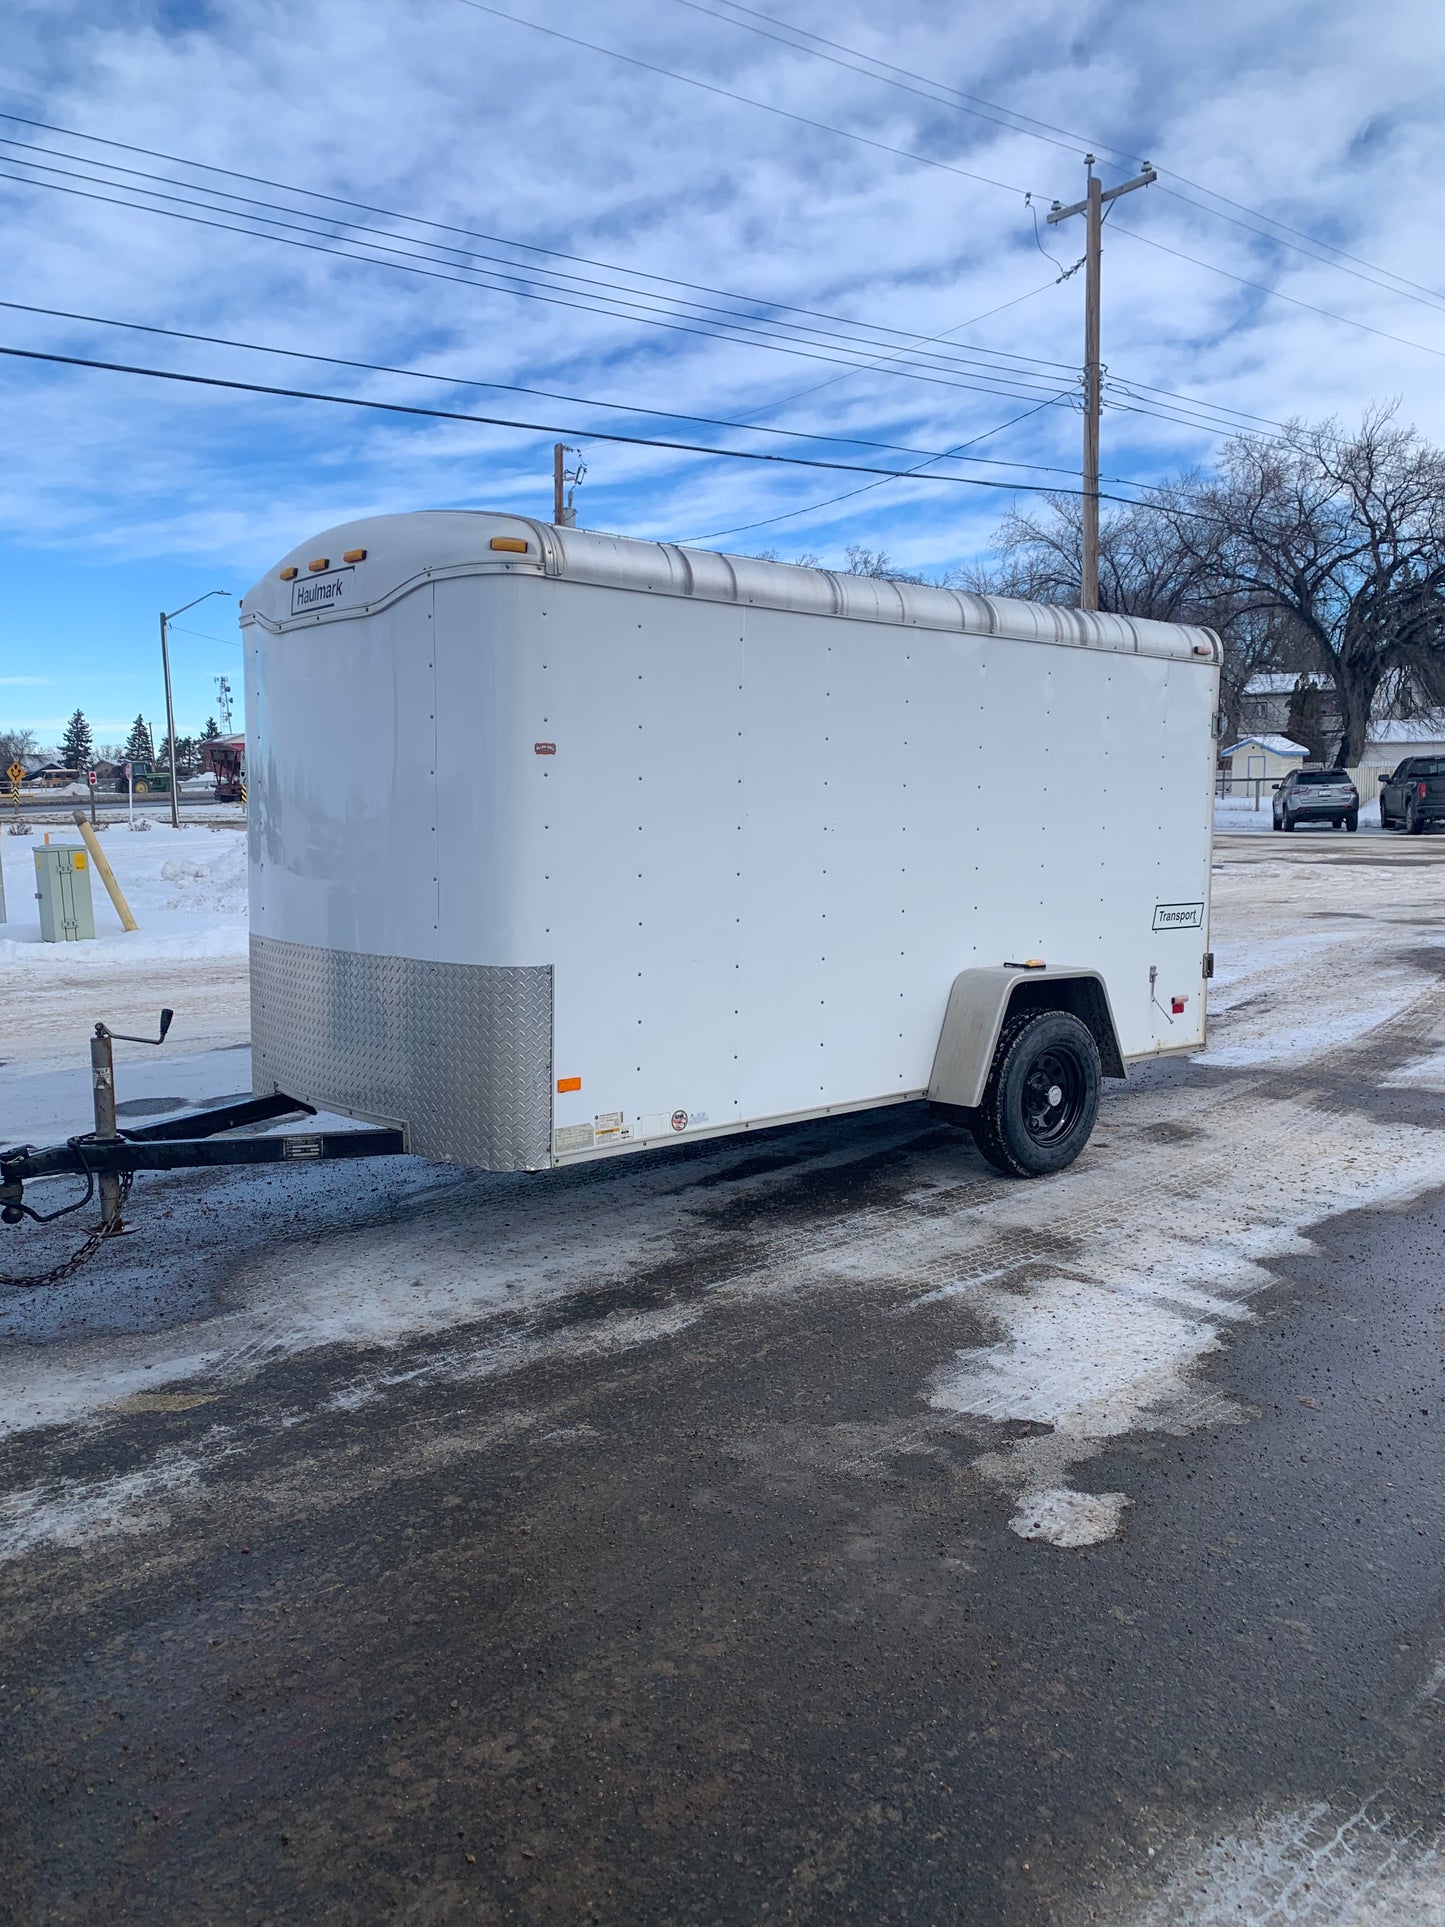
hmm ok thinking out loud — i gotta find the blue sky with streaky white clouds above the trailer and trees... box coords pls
[0,0,1445,742]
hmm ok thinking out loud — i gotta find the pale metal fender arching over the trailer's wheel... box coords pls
[929,964,1125,1112]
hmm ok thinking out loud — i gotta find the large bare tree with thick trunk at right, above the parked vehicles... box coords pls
[1162,407,1445,765]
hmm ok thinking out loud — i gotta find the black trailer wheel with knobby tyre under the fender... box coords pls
[971,1010,1100,1177]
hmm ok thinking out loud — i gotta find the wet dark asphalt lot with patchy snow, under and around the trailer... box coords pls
[0,832,1445,1927]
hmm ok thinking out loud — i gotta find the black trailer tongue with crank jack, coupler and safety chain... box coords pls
[0,1010,407,1287]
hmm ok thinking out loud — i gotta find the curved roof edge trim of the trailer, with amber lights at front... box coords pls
[241,509,1222,665]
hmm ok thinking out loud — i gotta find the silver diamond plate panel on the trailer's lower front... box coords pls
[250,937,551,1172]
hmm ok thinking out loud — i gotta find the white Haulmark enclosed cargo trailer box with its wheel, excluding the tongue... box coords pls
[241,513,1220,1175]
